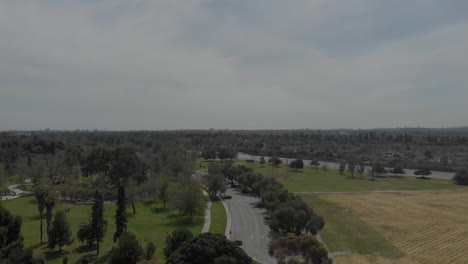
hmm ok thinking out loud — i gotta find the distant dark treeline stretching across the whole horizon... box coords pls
[0,128,468,173]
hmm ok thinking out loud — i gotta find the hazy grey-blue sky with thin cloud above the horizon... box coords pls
[0,0,468,130]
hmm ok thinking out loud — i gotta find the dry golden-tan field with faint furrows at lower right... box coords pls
[320,189,468,264]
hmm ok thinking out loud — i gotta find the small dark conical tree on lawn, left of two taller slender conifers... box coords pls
[49,210,72,252]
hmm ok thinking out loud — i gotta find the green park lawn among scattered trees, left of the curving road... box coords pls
[3,196,204,264]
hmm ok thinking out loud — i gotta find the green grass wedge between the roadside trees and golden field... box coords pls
[301,194,404,258]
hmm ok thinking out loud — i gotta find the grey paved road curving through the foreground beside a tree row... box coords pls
[225,188,276,264]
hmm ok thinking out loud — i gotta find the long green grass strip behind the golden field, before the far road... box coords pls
[237,161,460,192]
